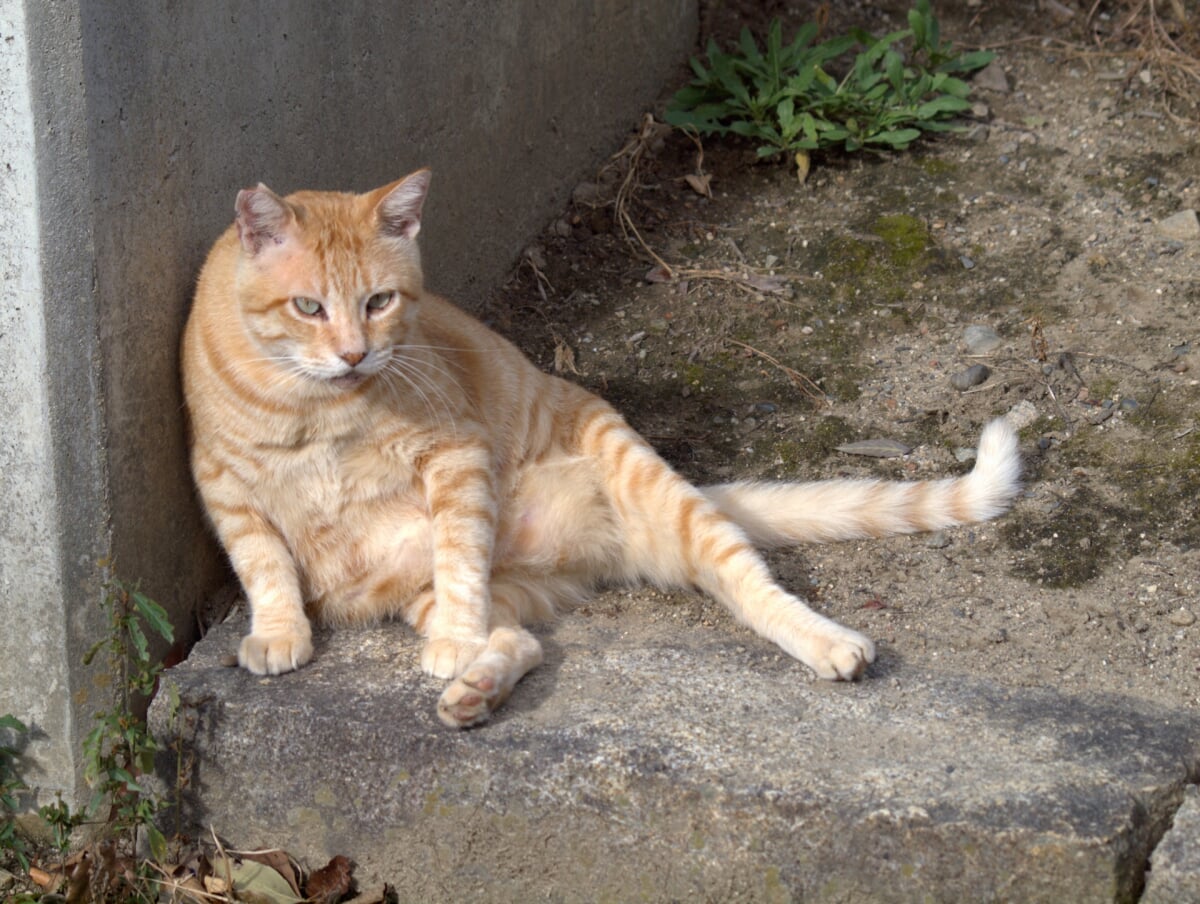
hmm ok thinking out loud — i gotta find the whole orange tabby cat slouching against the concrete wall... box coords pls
[182,169,1019,726]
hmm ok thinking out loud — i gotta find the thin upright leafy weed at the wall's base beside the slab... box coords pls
[83,579,174,860]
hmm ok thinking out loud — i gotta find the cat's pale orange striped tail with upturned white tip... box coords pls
[701,419,1021,546]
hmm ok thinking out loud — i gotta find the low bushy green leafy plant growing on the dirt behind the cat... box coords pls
[665,0,995,169]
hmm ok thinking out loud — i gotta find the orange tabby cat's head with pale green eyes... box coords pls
[226,169,430,391]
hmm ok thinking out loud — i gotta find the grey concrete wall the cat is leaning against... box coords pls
[0,0,696,797]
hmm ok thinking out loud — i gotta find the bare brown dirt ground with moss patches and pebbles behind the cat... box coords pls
[485,0,1200,710]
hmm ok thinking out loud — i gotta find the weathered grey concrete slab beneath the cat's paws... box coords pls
[152,601,1200,902]
